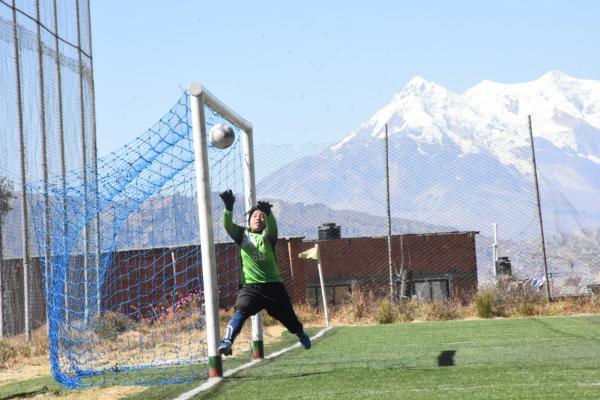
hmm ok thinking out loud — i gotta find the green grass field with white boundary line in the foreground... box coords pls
[0,316,600,400]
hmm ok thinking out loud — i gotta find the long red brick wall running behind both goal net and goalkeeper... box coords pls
[103,232,477,317]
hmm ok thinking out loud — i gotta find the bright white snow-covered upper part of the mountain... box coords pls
[333,71,600,174]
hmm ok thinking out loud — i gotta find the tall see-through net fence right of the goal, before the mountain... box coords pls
[256,120,600,305]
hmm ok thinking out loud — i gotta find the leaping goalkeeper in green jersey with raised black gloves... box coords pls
[219,190,311,356]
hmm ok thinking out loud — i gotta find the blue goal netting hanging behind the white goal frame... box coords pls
[29,94,251,387]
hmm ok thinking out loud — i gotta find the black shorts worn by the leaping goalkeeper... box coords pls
[235,282,303,333]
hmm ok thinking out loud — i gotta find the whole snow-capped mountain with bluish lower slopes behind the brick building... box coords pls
[258,72,600,237]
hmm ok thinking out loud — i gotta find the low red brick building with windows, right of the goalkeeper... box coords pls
[278,232,477,304]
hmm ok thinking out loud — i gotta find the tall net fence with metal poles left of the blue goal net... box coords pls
[0,0,95,335]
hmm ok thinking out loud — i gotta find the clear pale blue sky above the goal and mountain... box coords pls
[91,0,600,155]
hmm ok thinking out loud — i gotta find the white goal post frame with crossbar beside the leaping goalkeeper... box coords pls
[189,83,264,378]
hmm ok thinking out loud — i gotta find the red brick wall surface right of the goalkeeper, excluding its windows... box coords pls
[277,232,477,302]
